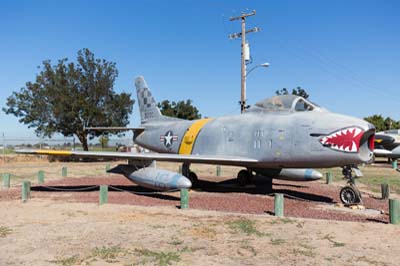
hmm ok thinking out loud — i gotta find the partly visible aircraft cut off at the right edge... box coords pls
[374,129,400,160]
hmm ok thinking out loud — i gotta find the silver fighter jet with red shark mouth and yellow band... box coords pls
[19,77,375,203]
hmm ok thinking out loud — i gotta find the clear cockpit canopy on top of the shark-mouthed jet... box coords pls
[249,95,322,112]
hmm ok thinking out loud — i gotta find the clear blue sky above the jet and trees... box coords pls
[0,0,400,140]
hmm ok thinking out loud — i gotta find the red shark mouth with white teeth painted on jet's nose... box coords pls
[319,127,364,153]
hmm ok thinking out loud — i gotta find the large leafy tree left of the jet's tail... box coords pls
[3,49,134,150]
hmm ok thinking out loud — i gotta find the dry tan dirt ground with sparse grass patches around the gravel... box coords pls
[0,159,400,265]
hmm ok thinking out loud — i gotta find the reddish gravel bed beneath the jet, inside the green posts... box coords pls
[0,175,389,223]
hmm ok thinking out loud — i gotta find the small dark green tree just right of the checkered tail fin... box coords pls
[158,99,201,120]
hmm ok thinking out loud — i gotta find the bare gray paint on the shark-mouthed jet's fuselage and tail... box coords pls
[135,77,374,168]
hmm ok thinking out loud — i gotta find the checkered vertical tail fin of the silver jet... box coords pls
[135,76,163,124]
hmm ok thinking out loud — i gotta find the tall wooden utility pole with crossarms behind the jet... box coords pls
[229,10,261,113]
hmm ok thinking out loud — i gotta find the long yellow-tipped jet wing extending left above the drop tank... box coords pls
[16,149,258,166]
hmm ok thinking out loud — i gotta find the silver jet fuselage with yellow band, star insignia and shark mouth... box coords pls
[135,95,374,168]
